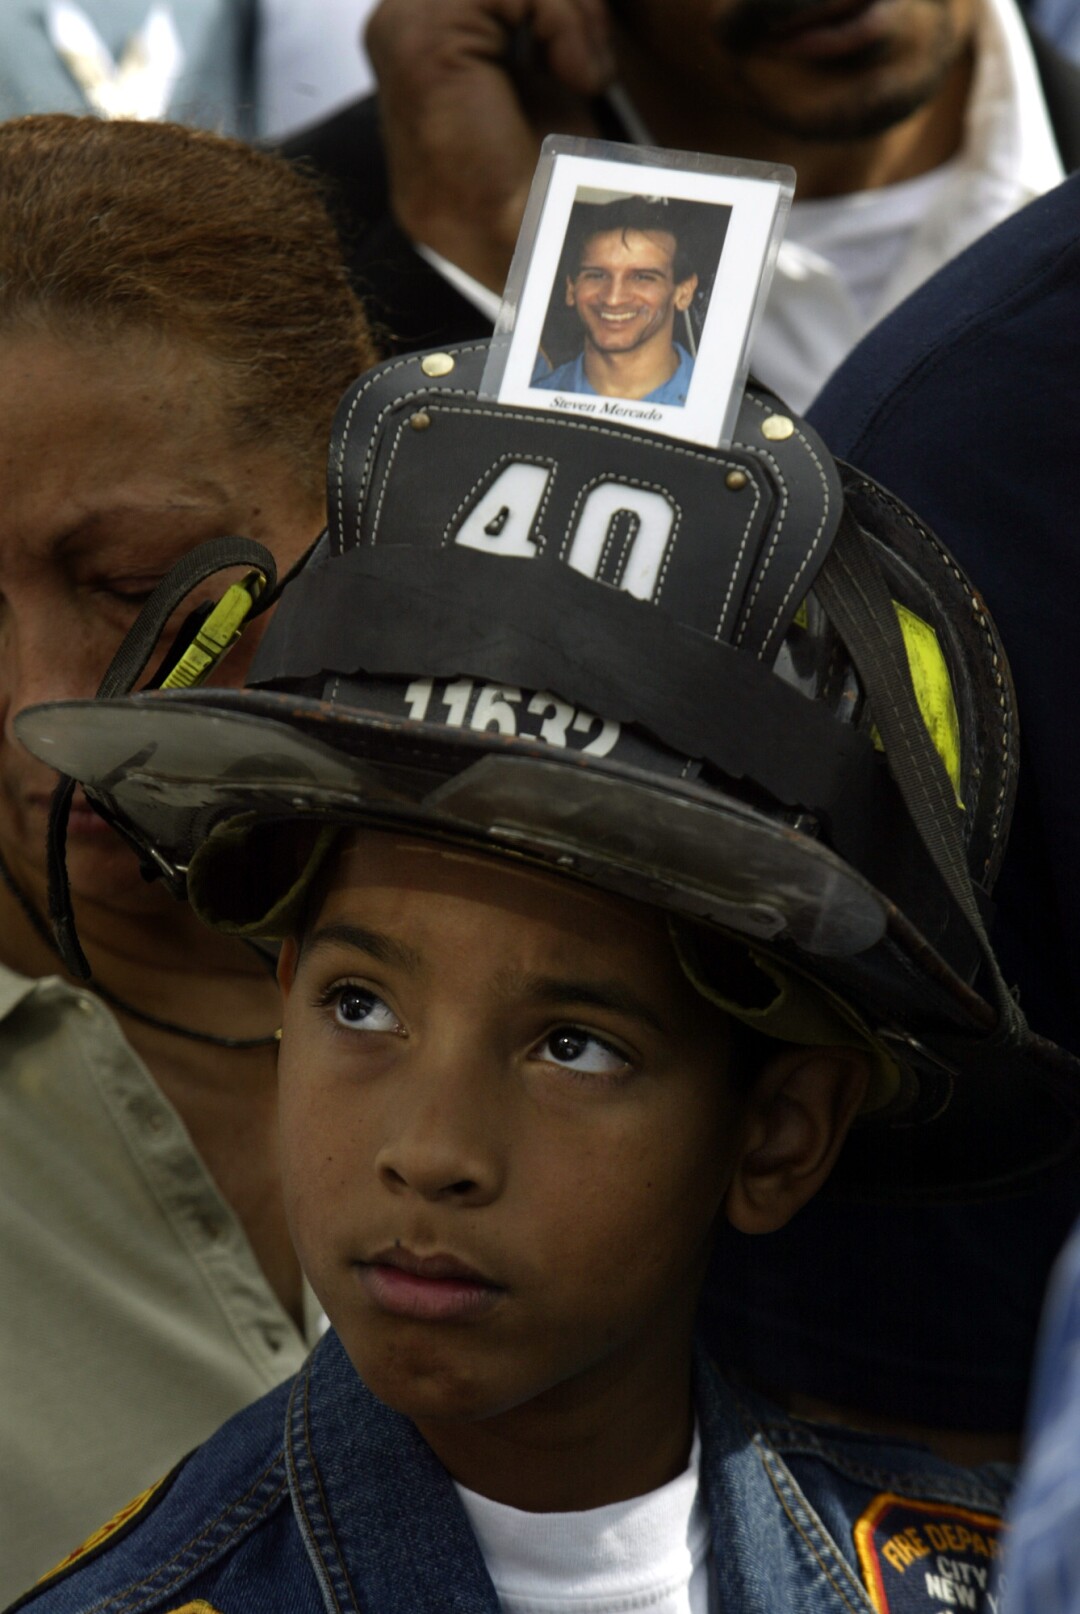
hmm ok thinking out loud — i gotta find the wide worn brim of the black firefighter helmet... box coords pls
[18,689,1080,1199]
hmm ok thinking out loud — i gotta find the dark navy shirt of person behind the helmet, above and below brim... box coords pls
[703,178,1080,1430]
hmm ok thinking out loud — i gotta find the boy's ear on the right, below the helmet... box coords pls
[725,1047,870,1233]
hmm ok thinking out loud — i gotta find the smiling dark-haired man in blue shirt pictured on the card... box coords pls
[534,197,697,405]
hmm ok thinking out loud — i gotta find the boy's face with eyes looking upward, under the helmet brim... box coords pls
[281,831,741,1422]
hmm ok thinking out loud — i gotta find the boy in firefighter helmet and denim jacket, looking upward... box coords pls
[10,349,1077,1614]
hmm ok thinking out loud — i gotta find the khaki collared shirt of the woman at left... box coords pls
[0,965,321,1606]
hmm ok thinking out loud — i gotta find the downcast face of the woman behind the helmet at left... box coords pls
[0,331,323,902]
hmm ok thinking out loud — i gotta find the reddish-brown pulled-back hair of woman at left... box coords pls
[0,115,378,487]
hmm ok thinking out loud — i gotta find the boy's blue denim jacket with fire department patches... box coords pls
[15,1333,1006,1614]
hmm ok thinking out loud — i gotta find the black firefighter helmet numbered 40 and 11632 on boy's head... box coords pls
[18,344,1080,1199]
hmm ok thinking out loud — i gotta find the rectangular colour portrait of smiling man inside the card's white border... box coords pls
[533,195,730,407]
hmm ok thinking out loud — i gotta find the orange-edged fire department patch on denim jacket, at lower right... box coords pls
[856,1491,1004,1614]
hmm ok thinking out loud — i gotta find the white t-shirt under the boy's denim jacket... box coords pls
[457,1433,710,1614]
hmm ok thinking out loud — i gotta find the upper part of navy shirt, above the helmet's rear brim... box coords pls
[809,176,1080,1052]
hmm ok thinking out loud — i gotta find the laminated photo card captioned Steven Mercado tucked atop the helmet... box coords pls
[483,137,793,444]
